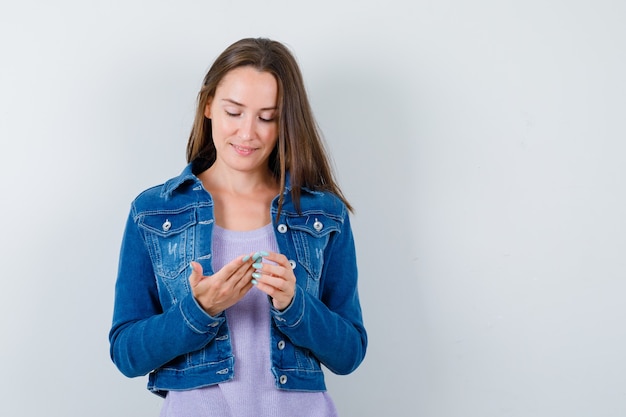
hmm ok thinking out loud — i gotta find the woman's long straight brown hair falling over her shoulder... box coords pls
[187,38,353,213]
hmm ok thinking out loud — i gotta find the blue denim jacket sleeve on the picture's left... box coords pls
[109,208,225,377]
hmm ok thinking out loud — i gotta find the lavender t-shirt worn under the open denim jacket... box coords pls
[161,224,337,417]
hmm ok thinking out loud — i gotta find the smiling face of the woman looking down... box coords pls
[204,67,278,176]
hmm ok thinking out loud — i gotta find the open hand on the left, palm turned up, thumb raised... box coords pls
[189,256,254,317]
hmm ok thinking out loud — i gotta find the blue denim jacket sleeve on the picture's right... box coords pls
[272,208,367,375]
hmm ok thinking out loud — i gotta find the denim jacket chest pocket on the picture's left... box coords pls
[138,208,197,288]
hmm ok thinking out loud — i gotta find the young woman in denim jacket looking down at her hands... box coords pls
[109,38,367,417]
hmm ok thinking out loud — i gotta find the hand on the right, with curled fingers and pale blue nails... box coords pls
[252,252,296,311]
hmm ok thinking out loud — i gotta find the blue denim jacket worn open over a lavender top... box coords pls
[109,163,367,396]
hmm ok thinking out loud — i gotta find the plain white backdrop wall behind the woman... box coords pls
[0,0,626,417]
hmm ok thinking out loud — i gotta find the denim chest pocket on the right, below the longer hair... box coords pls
[285,213,341,297]
